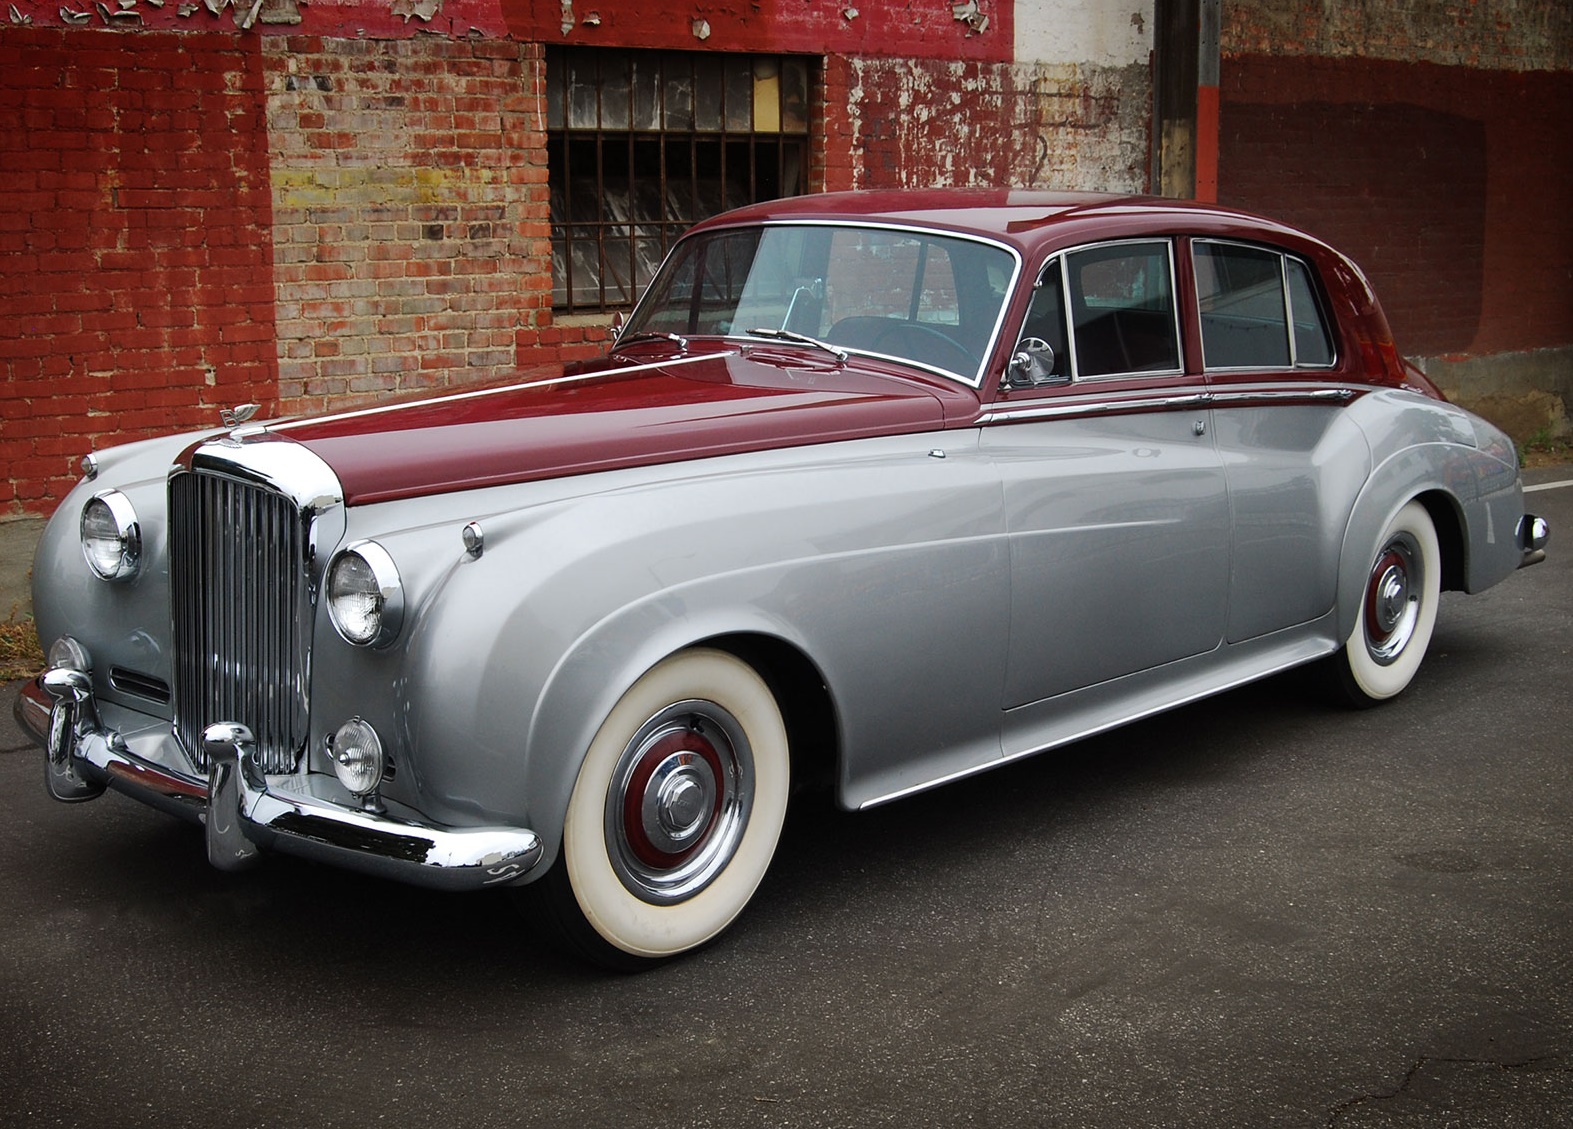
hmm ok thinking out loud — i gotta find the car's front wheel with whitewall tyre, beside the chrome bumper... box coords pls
[524,648,791,969]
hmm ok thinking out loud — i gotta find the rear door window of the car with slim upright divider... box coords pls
[1192,239,1332,370]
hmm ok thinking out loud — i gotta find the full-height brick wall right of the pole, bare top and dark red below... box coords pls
[1219,0,1573,439]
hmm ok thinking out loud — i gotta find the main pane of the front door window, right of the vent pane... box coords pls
[1065,241,1180,377]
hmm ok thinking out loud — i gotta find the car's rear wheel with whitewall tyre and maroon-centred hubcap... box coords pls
[1331,502,1442,706]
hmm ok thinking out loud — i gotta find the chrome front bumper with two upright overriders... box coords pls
[14,670,541,890]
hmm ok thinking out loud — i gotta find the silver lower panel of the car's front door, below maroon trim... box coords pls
[983,407,1229,708]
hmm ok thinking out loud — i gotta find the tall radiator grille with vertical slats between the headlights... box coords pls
[170,473,310,772]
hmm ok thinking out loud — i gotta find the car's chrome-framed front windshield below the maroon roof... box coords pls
[623,223,1016,385]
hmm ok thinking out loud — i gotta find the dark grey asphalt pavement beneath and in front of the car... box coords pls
[0,469,1573,1129]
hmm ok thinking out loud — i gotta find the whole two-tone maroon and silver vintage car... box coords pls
[16,190,1546,967]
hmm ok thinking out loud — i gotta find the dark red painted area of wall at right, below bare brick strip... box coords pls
[1219,55,1573,355]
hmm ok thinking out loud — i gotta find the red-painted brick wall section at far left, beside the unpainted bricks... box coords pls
[0,27,277,514]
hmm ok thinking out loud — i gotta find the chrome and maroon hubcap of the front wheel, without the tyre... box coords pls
[606,700,753,904]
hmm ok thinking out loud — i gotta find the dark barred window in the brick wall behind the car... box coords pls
[546,47,810,313]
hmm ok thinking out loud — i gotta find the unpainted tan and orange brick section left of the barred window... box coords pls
[264,36,554,412]
